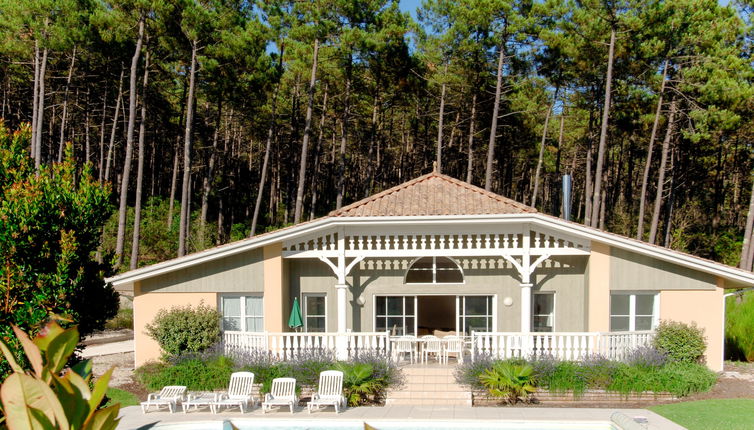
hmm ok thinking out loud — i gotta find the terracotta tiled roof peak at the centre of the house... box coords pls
[329,172,537,217]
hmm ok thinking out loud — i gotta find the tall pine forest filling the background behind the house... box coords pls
[0,0,754,271]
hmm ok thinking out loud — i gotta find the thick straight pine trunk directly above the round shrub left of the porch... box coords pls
[178,40,198,257]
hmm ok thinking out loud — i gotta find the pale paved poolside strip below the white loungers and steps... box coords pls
[118,405,684,430]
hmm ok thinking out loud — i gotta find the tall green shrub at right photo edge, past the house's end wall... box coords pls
[725,292,754,361]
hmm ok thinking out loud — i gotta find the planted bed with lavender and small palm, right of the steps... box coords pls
[456,347,717,404]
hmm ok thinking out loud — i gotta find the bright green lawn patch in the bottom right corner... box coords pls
[649,399,754,430]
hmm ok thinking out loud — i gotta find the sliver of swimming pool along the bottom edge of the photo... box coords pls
[148,419,621,430]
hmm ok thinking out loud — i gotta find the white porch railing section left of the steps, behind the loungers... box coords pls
[223,331,390,360]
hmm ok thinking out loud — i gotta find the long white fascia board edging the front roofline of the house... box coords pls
[105,214,754,286]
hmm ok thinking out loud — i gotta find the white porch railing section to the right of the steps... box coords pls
[471,331,654,360]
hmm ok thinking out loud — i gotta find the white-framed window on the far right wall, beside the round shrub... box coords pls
[610,293,658,331]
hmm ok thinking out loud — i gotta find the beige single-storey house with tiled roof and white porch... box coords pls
[108,173,754,370]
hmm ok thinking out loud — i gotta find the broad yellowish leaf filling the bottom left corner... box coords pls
[0,373,69,430]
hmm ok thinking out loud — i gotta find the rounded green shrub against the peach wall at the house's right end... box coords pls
[652,321,707,363]
